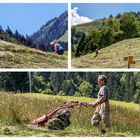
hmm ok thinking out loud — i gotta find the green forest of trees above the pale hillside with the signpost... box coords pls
[71,12,140,57]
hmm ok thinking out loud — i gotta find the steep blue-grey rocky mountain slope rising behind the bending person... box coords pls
[31,11,68,51]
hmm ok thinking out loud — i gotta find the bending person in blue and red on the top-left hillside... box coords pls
[50,41,64,55]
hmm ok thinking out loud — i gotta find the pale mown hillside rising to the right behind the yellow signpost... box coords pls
[72,38,140,68]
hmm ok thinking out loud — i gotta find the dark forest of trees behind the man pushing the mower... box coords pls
[0,72,140,103]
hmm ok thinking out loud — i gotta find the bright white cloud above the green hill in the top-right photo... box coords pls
[71,7,92,25]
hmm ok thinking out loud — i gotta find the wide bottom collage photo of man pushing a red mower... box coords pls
[0,71,140,137]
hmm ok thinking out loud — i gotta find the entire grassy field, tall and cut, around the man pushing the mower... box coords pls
[0,92,140,137]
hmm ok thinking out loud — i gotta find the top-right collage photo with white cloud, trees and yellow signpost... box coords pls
[71,3,140,69]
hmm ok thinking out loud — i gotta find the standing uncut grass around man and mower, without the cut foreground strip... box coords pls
[0,93,140,136]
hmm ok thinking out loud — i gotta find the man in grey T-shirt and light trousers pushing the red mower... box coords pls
[90,75,110,133]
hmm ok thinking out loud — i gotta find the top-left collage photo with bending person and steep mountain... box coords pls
[0,3,68,69]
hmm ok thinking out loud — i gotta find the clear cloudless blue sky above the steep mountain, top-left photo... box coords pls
[0,3,68,35]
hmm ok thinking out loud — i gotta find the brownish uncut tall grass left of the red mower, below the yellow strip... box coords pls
[0,93,64,124]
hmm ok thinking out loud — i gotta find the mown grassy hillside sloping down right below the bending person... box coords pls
[0,40,67,68]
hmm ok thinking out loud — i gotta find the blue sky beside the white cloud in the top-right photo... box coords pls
[72,3,140,19]
